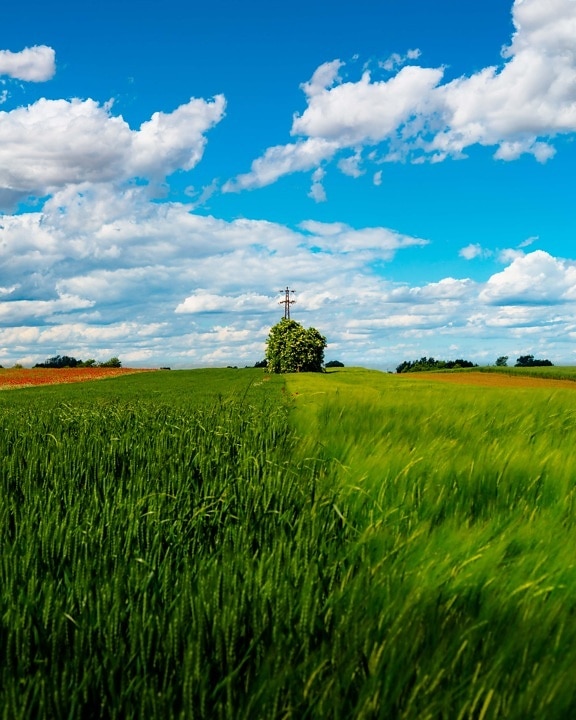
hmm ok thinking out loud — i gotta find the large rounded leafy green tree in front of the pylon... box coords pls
[266,318,327,373]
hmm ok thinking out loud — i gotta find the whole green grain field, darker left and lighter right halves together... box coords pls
[0,368,576,720]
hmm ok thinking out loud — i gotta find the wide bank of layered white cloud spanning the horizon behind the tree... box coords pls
[0,176,576,366]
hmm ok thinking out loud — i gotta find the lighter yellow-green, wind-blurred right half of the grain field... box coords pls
[287,370,576,718]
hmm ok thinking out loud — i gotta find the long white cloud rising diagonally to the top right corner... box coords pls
[224,0,576,191]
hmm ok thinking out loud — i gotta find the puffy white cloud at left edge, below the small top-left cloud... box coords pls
[0,95,225,201]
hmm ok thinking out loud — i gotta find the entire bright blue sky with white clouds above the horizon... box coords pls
[0,0,576,369]
